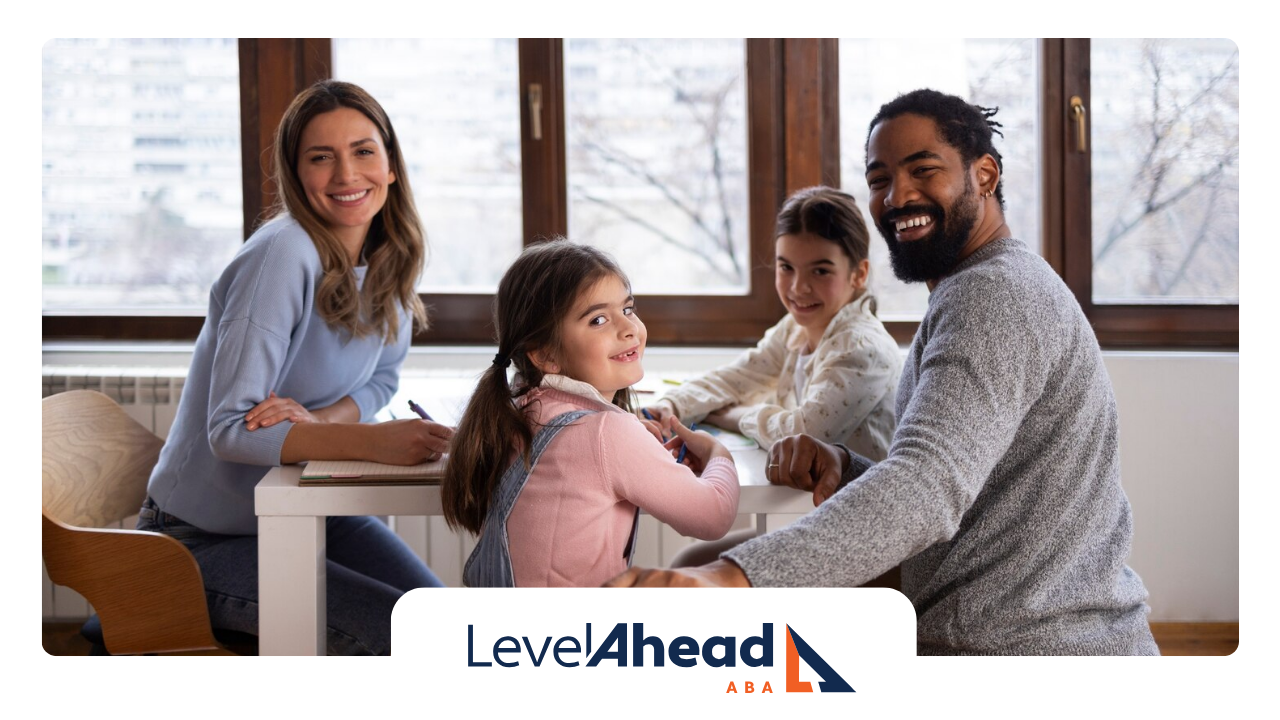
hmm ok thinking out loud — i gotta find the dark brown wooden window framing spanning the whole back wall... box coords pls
[42,38,1239,348]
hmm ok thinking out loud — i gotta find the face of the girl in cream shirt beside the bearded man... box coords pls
[773,233,868,340]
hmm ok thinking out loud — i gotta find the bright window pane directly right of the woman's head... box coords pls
[333,40,524,293]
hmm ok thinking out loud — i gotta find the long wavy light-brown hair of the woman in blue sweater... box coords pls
[271,79,426,345]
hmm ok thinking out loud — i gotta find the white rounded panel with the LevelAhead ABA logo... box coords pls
[392,588,915,707]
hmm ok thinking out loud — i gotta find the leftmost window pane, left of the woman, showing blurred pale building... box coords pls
[41,40,243,315]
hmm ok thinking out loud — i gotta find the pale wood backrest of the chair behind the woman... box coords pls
[41,389,164,528]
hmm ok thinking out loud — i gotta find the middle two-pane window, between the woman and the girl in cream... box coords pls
[325,38,782,343]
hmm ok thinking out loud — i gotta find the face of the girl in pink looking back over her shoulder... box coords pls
[532,274,649,400]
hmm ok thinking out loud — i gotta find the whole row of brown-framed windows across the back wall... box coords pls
[41,38,1239,347]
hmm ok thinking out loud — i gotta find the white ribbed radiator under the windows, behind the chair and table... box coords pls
[41,366,732,621]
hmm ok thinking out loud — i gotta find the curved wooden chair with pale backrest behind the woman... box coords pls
[41,389,232,655]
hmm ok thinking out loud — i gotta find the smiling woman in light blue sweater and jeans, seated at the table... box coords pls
[138,81,453,653]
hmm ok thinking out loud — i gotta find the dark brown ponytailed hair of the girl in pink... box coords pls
[440,238,632,533]
